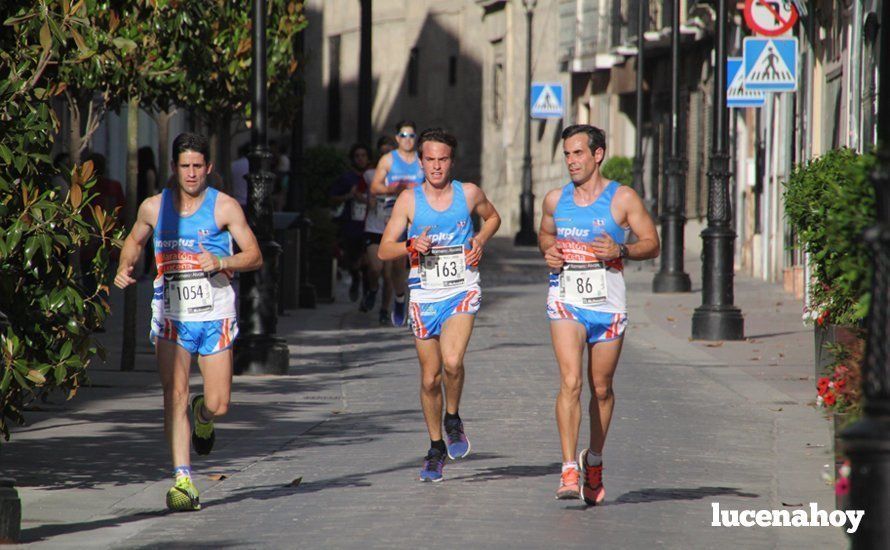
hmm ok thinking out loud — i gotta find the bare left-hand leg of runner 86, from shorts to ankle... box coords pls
[550,321,587,462]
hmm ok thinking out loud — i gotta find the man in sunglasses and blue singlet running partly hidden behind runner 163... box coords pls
[369,120,423,327]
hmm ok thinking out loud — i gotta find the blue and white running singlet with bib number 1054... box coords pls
[151,187,236,326]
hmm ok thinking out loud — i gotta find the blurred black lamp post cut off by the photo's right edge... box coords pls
[843,3,890,550]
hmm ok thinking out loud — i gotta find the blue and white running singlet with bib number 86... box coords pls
[547,181,627,318]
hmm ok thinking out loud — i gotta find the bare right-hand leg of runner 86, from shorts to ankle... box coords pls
[587,337,624,454]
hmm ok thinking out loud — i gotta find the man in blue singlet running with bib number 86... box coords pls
[538,124,659,505]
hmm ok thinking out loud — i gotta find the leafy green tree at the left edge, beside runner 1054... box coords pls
[0,0,120,439]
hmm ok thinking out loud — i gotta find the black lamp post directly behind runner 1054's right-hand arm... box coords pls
[235,0,288,374]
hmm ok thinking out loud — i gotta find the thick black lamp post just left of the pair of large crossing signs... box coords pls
[692,0,745,340]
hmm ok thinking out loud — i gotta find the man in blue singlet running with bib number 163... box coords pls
[378,128,501,481]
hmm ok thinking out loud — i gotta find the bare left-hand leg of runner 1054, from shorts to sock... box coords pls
[155,338,192,468]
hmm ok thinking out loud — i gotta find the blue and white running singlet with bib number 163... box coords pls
[408,180,479,303]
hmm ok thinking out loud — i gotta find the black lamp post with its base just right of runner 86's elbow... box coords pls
[652,0,692,293]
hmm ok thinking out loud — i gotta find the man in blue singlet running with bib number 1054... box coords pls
[114,133,263,511]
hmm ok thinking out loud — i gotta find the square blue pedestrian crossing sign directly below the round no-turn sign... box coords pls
[744,36,797,92]
